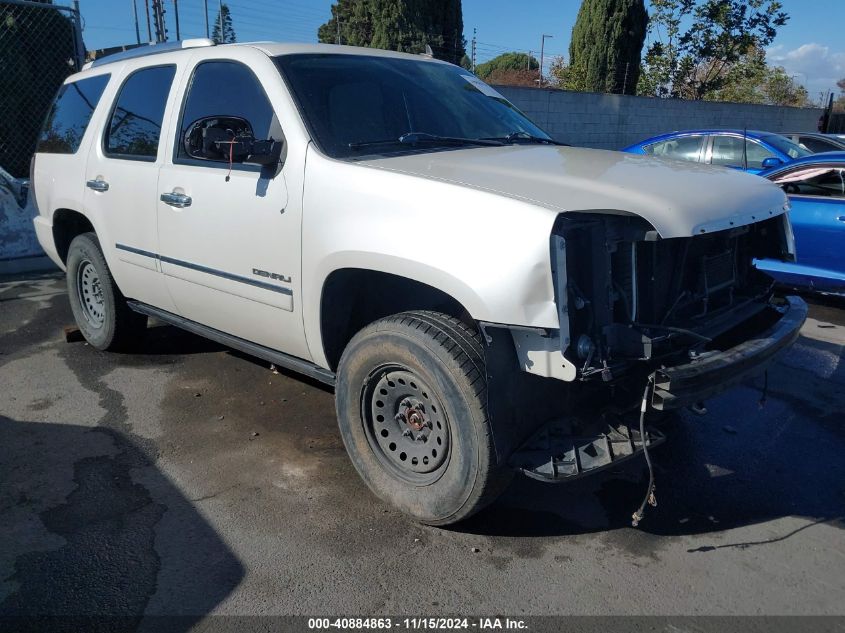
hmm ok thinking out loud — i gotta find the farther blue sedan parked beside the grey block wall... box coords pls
[622,130,812,174]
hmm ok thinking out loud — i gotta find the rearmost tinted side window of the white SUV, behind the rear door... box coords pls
[35,75,111,154]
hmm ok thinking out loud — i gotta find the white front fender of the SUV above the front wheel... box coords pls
[302,150,559,364]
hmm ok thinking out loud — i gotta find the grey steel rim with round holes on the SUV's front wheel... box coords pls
[361,366,450,486]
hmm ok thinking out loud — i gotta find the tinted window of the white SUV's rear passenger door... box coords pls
[103,66,176,161]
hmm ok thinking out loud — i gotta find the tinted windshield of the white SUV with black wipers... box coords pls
[276,54,550,158]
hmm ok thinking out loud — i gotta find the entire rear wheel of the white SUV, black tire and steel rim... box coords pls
[67,233,147,351]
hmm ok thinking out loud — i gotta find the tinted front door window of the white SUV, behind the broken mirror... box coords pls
[176,61,282,163]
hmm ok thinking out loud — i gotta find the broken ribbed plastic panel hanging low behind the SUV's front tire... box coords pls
[510,415,666,482]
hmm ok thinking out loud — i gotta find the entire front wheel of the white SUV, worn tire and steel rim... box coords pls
[335,312,512,525]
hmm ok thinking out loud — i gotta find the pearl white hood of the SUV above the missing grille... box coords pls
[363,145,788,238]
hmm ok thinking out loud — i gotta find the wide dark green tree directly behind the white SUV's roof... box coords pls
[317,0,466,64]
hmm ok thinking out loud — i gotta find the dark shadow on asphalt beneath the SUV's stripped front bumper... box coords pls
[456,328,845,540]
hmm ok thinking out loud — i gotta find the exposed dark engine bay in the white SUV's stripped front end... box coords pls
[552,213,793,382]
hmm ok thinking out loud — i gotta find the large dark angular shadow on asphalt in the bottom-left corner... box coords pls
[0,417,244,631]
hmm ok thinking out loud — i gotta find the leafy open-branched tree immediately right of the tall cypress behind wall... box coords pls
[638,0,789,99]
